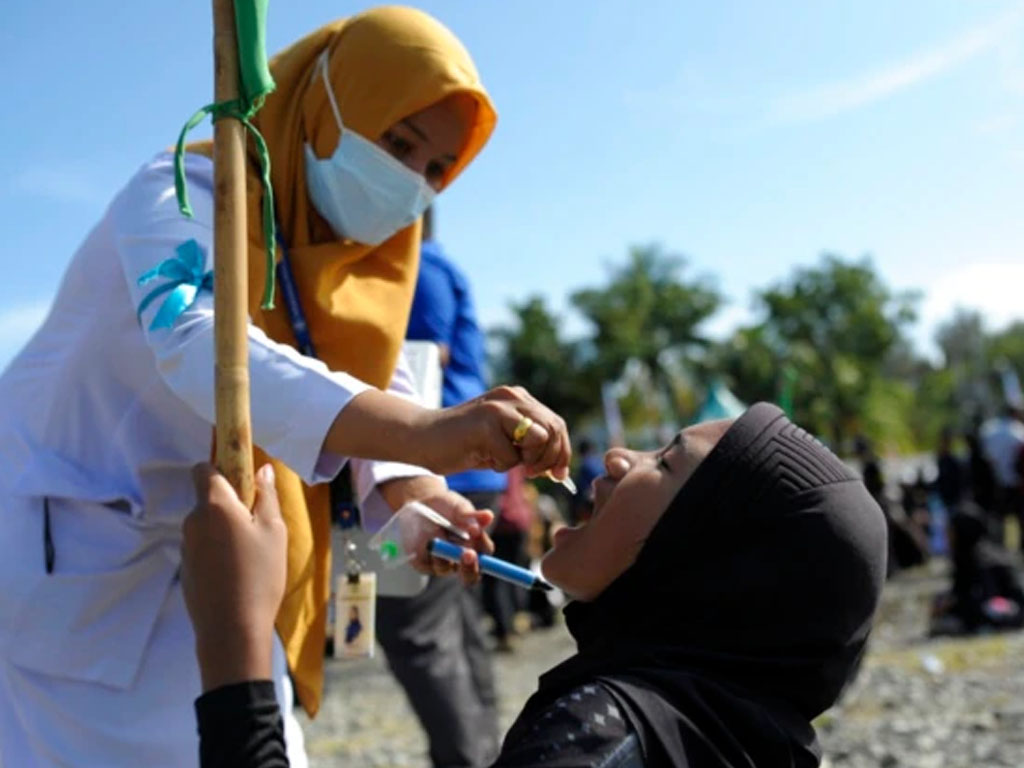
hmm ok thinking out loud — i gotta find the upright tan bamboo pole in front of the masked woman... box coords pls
[213,0,255,508]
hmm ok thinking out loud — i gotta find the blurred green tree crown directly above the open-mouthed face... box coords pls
[571,246,721,421]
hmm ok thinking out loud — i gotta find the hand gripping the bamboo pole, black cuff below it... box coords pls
[181,464,288,691]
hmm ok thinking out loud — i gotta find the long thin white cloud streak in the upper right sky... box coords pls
[770,4,1024,123]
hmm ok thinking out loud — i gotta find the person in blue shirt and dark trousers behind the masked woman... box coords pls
[377,207,507,768]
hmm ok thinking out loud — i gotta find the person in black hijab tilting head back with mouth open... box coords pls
[496,403,886,768]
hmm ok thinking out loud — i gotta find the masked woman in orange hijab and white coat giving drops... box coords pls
[0,7,569,766]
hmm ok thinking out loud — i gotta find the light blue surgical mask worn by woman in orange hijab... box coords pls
[305,50,434,246]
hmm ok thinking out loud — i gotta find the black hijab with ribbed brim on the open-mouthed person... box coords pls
[521,403,887,768]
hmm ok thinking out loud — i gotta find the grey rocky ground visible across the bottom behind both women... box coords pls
[304,564,1024,768]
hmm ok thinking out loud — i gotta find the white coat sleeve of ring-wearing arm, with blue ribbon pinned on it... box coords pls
[111,155,369,483]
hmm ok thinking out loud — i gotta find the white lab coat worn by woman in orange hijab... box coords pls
[0,155,432,768]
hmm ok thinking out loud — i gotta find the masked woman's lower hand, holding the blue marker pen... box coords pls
[377,476,495,585]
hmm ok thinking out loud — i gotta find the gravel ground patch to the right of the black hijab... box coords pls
[816,566,1024,768]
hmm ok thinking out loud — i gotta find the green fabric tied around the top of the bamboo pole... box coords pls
[174,0,276,309]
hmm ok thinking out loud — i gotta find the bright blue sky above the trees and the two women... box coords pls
[0,0,1024,372]
